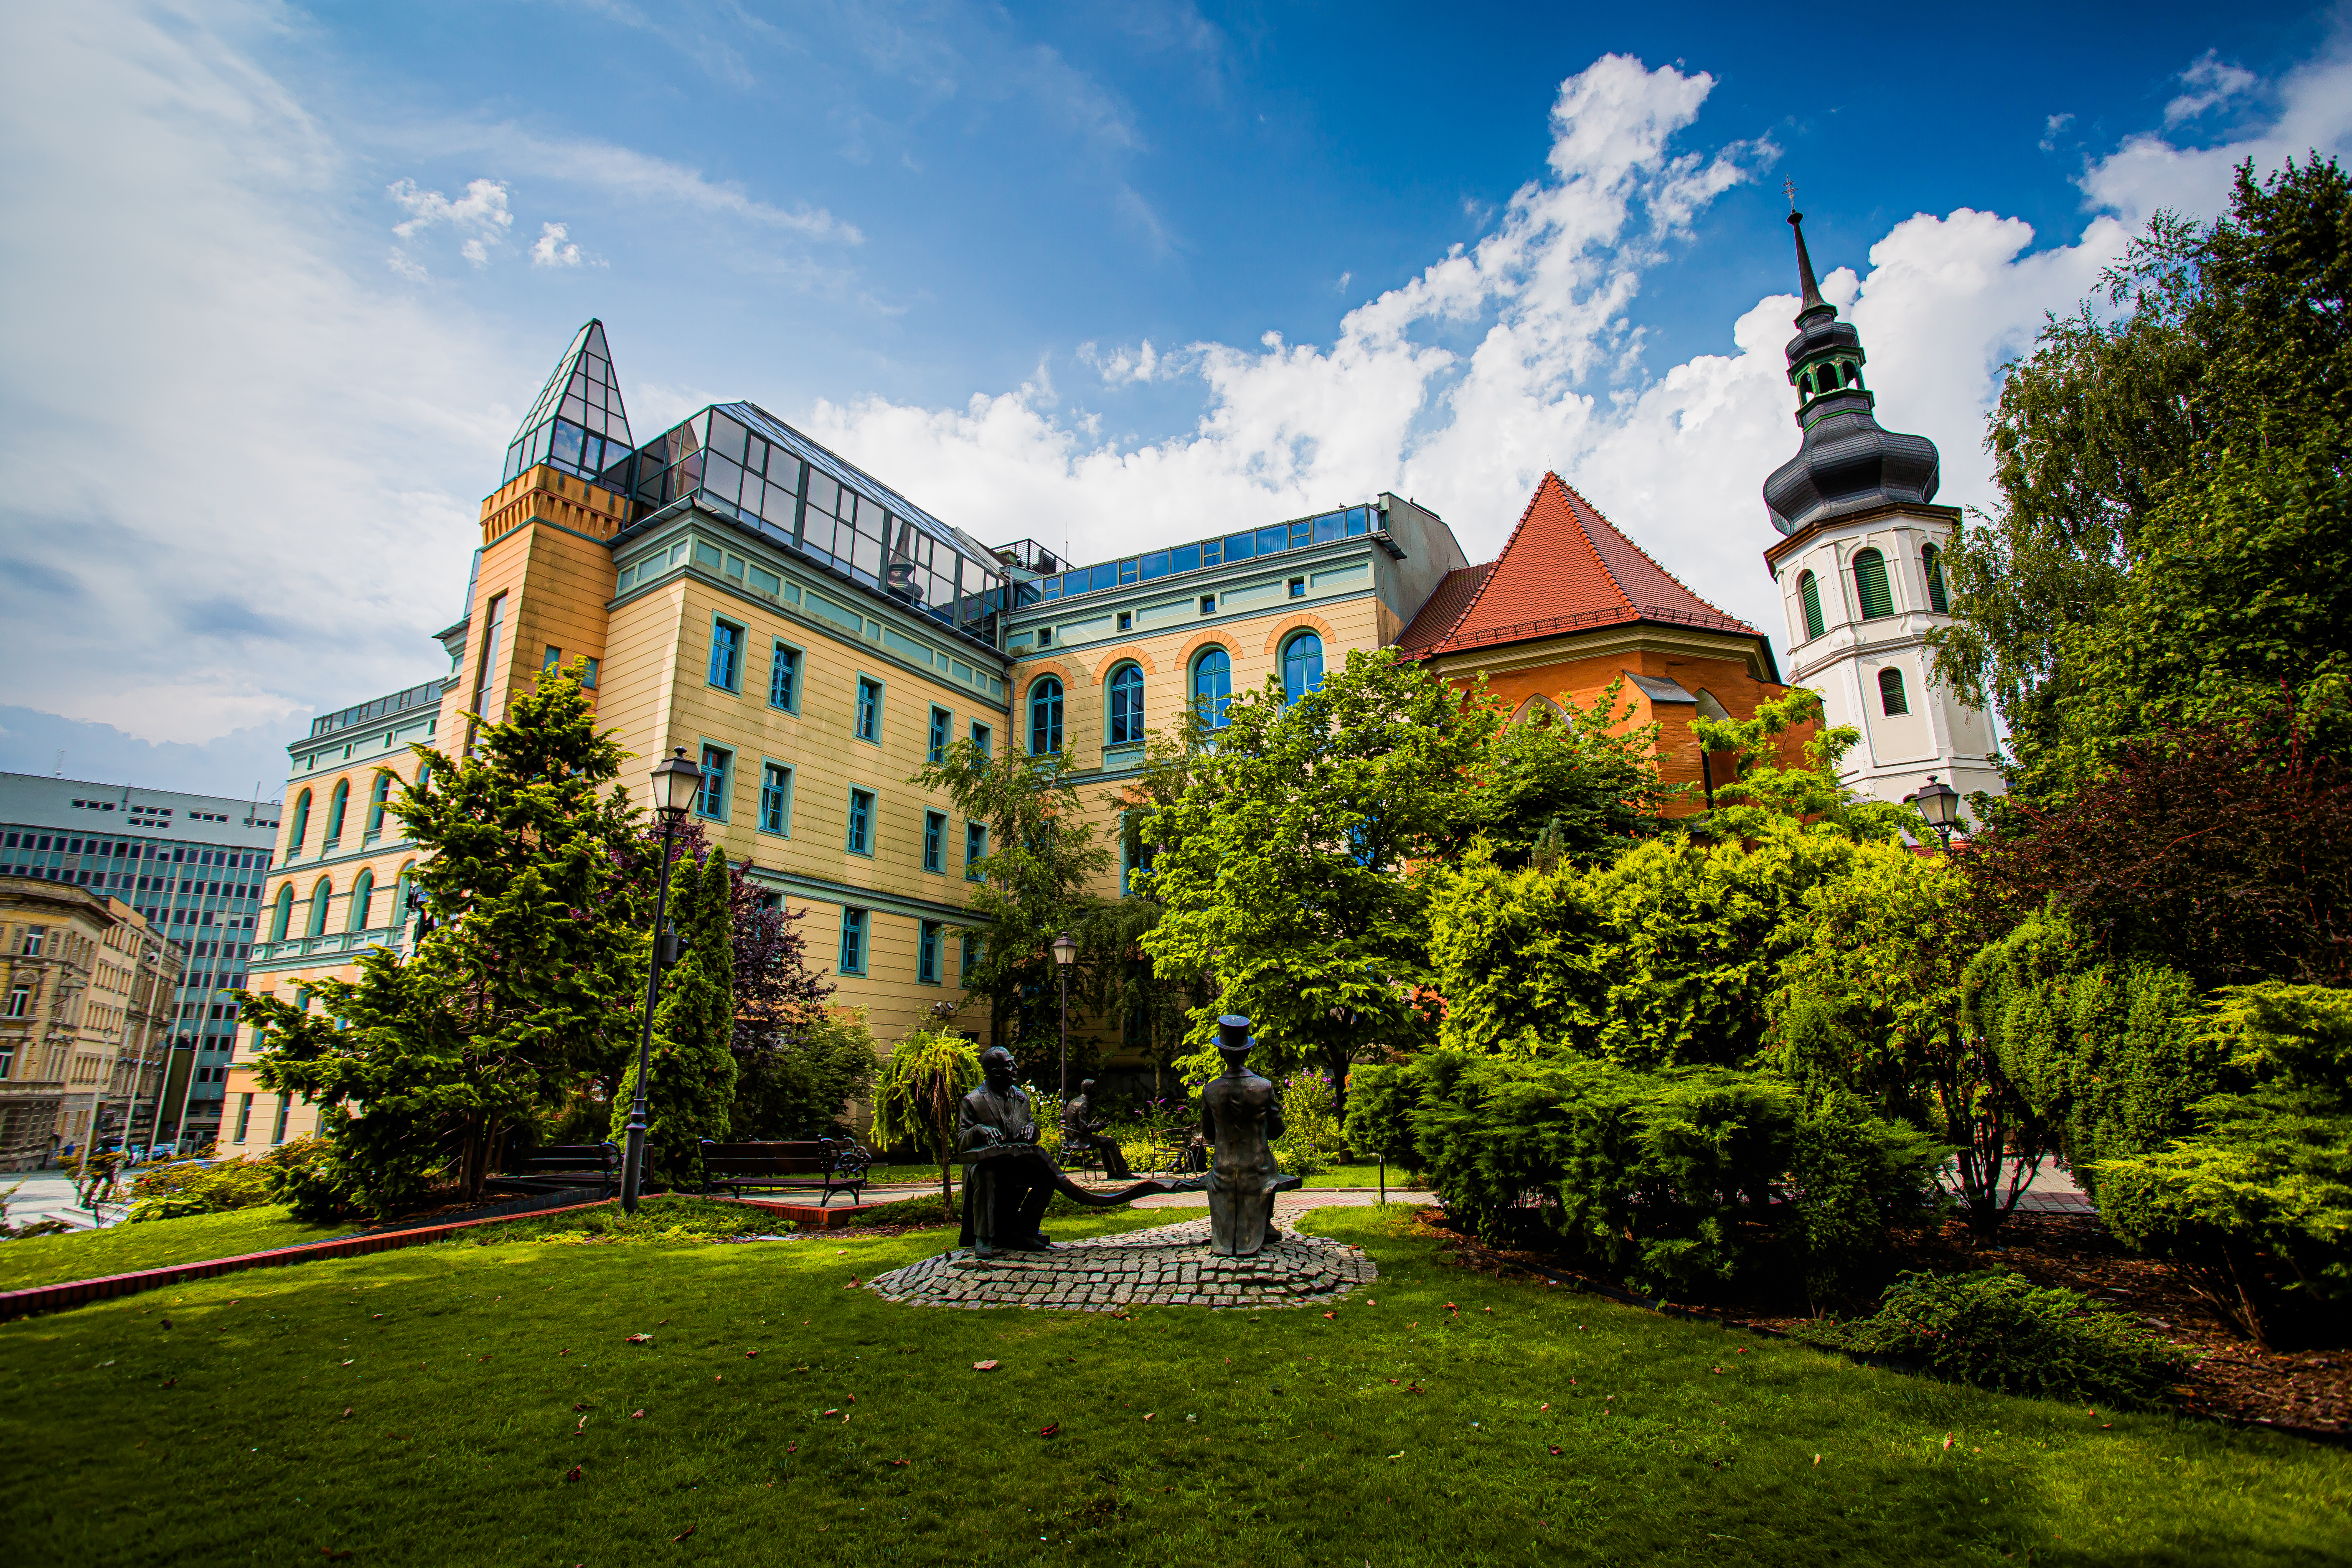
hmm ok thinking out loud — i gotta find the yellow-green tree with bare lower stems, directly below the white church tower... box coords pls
[1762,844,2049,1234]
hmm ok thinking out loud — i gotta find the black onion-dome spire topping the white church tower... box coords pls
[1764,208,1941,534]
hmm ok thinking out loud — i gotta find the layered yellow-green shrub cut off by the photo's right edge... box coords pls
[2095,983,2352,1344]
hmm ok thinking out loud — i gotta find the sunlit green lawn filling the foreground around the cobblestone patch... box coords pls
[0,1206,2352,1568]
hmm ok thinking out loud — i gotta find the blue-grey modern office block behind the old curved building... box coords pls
[0,773,277,1138]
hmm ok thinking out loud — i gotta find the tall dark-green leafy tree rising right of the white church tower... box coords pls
[1931,155,2352,795]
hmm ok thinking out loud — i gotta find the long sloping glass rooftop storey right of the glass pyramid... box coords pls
[611,402,1007,649]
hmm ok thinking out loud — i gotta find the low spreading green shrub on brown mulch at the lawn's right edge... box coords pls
[1797,1272,2190,1406]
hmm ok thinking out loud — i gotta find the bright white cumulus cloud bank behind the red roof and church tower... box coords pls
[809,43,2352,639]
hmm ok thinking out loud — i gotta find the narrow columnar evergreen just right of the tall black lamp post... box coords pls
[612,851,736,1189]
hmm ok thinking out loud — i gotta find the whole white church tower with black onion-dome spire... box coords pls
[1764,211,2001,802]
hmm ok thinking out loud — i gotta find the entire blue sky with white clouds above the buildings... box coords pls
[0,0,2352,795]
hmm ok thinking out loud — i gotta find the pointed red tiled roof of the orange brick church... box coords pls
[1397,473,1759,658]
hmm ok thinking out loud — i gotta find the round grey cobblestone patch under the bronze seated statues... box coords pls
[866,1218,1378,1312]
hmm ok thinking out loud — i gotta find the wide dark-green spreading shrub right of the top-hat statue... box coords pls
[1348,1051,1943,1293]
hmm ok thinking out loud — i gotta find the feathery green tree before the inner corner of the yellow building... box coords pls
[912,740,1113,1067]
